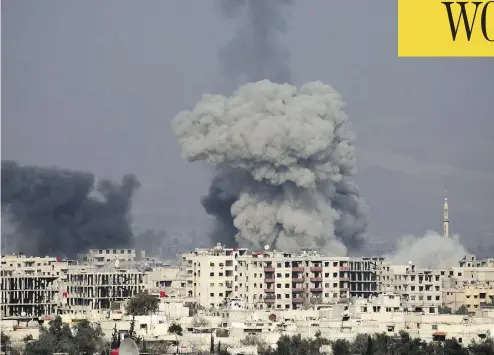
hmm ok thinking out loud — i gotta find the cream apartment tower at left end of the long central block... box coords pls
[180,243,247,308]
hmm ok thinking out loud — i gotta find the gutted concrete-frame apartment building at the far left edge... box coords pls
[0,255,71,318]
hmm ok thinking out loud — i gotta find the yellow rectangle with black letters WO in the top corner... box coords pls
[398,0,494,57]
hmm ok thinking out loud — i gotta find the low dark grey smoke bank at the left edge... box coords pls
[2,161,139,257]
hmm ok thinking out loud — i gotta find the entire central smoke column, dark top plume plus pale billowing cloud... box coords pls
[183,0,369,253]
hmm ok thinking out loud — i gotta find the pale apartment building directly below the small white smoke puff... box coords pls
[379,263,442,313]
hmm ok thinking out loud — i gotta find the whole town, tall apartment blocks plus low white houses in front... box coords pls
[1,239,494,353]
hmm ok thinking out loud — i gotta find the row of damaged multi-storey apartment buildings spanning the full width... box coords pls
[0,244,494,318]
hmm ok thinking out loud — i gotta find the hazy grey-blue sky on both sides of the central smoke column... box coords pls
[2,0,494,256]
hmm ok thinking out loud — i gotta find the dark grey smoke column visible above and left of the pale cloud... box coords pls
[201,0,292,246]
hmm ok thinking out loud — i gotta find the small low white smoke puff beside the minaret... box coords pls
[385,231,468,268]
